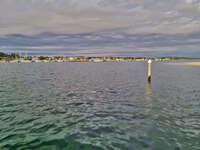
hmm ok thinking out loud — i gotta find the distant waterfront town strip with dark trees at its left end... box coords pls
[0,52,200,63]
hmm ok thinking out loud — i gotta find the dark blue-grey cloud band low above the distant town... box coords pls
[0,30,200,57]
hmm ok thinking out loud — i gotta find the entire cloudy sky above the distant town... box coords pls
[0,0,200,57]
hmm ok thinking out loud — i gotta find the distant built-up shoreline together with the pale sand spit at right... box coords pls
[0,56,200,63]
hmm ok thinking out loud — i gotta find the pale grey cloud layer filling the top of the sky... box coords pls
[0,0,200,35]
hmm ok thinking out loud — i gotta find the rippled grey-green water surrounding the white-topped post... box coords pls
[0,62,200,150]
